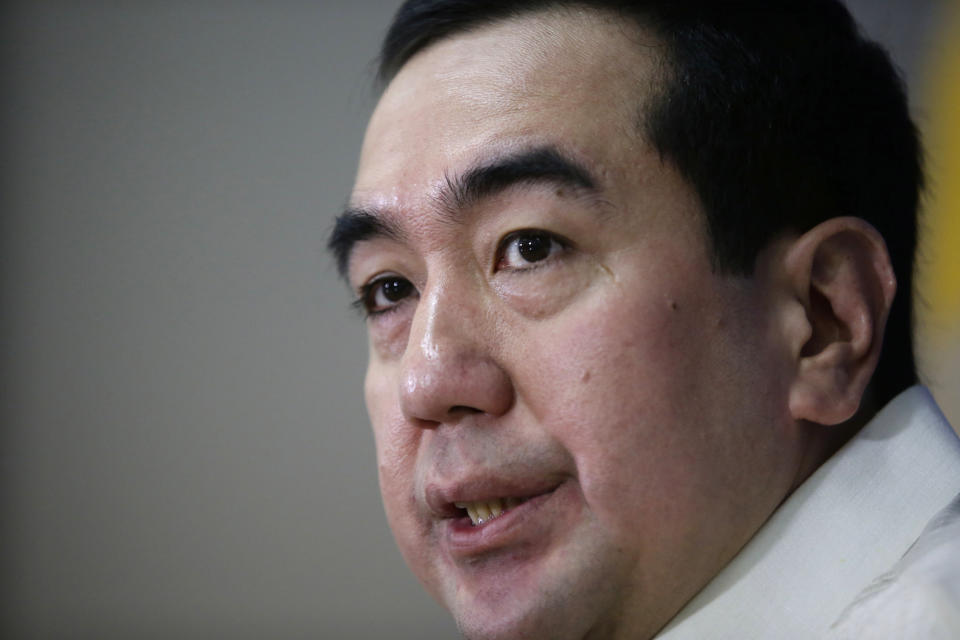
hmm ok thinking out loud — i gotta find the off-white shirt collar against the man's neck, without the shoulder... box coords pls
[658,386,960,640]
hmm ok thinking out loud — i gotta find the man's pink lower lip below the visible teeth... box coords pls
[443,483,571,558]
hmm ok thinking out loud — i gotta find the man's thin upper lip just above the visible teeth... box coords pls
[425,474,562,518]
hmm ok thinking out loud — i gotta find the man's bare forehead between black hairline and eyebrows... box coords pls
[354,10,659,207]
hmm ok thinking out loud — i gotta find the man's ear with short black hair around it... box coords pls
[785,217,897,425]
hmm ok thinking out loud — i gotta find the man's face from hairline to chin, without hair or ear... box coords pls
[349,13,802,638]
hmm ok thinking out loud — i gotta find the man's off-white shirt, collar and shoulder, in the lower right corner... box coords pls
[658,386,960,640]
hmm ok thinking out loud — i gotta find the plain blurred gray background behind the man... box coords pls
[0,0,956,639]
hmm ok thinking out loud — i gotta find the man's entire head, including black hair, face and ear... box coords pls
[331,1,919,638]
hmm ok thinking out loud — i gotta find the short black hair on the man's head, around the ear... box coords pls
[380,0,924,404]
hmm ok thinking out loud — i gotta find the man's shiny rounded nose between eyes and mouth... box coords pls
[400,286,514,426]
